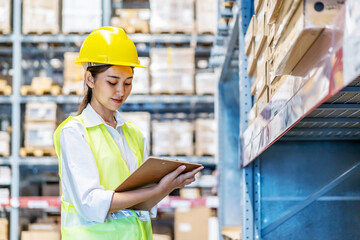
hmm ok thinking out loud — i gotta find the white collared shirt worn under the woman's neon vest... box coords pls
[60,104,152,222]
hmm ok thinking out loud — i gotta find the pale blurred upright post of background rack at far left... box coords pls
[10,0,22,240]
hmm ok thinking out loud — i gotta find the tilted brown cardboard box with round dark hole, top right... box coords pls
[274,0,343,75]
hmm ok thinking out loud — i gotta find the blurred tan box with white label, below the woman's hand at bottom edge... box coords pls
[175,207,211,240]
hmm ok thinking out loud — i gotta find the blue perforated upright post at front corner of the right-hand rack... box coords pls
[238,0,261,240]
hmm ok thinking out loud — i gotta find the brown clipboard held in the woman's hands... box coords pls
[115,157,202,211]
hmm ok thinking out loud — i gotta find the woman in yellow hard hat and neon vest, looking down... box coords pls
[54,27,202,240]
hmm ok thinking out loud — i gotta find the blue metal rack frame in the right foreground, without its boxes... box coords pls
[212,0,360,240]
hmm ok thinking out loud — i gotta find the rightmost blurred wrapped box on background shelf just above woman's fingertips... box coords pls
[195,119,216,156]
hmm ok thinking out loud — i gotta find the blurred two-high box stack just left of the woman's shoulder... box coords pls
[24,103,57,148]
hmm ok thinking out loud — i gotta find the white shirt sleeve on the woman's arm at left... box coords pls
[60,122,114,222]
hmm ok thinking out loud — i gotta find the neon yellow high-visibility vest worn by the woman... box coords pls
[54,115,152,240]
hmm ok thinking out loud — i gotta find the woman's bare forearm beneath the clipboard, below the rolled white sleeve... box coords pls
[109,185,165,213]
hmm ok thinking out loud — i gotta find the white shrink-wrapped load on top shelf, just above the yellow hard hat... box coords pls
[62,0,102,33]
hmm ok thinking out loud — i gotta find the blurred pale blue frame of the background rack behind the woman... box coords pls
[0,0,216,240]
